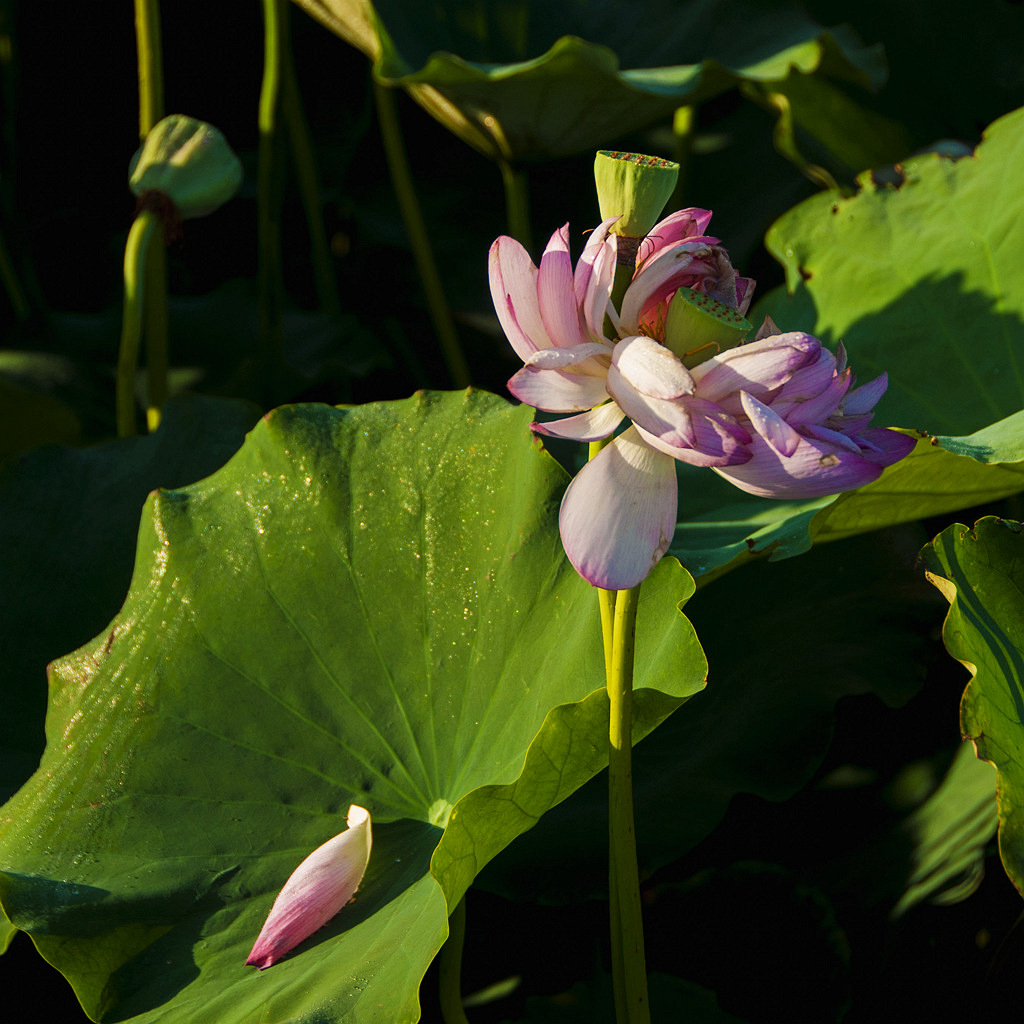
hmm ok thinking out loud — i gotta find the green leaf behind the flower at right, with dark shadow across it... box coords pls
[671,111,1024,577]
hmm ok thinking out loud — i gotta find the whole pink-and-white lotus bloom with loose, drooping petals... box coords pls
[489,216,914,590]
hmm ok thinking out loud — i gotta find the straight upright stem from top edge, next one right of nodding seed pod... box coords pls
[256,0,288,403]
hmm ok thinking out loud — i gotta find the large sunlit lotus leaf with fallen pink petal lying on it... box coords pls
[0,391,706,1024]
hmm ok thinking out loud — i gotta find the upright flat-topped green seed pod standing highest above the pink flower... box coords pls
[594,150,679,239]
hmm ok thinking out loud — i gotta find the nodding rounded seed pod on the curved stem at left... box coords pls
[128,114,242,220]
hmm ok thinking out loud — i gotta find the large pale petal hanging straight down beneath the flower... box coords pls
[558,427,678,590]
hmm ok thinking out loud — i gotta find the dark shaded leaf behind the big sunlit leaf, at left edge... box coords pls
[0,395,259,800]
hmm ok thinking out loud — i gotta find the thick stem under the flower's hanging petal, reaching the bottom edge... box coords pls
[607,586,650,1024]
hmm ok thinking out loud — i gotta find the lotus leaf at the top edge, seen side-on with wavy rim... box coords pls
[298,0,884,160]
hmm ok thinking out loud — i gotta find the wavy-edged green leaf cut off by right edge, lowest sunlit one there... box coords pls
[922,516,1024,894]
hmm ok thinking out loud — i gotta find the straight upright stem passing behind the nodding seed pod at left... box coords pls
[135,0,168,432]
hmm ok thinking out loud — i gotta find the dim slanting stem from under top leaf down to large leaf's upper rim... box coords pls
[374,81,470,388]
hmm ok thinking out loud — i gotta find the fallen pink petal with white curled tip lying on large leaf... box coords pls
[246,804,373,971]
